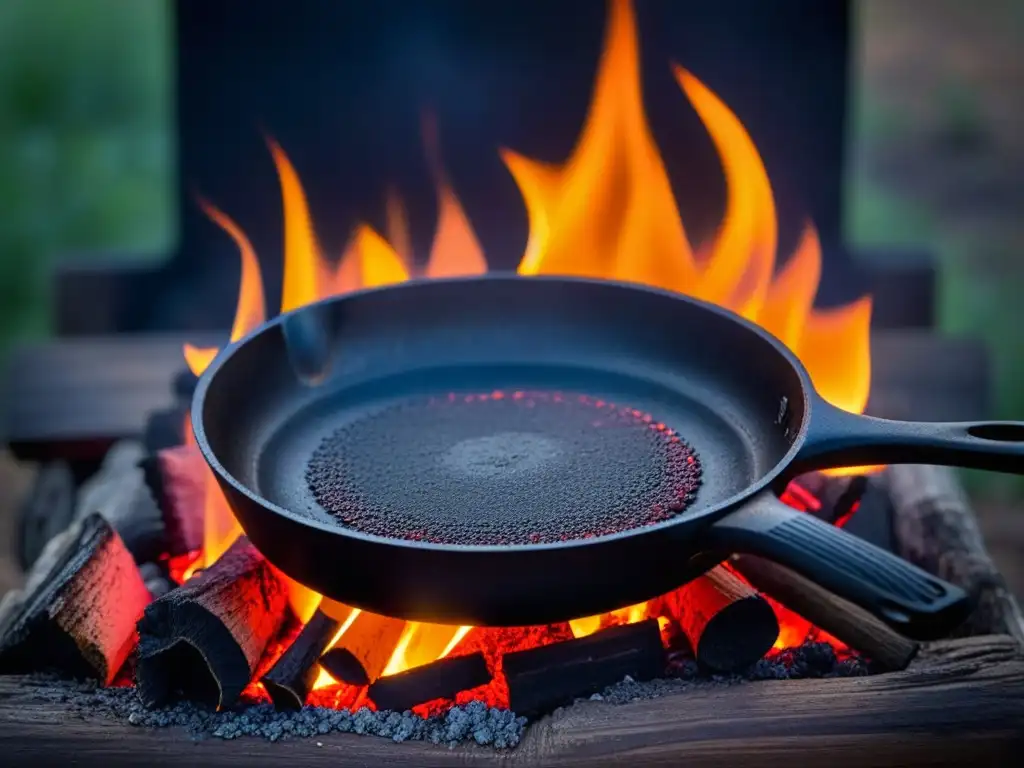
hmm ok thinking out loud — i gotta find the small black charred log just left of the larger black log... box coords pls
[369,651,490,712]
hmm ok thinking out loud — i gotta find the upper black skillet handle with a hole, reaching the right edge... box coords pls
[790,397,1024,476]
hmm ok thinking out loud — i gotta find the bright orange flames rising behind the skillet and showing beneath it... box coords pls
[184,0,872,687]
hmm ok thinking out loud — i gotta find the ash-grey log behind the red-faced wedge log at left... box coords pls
[76,440,165,562]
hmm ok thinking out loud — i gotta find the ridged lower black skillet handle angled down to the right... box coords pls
[702,493,969,640]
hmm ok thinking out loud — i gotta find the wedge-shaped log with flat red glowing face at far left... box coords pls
[0,514,150,684]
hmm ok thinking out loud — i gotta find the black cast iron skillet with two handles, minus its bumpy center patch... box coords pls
[191,274,1024,639]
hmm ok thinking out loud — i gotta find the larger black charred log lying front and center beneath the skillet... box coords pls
[502,618,665,717]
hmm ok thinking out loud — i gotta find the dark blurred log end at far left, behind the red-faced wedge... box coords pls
[17,461,77,570]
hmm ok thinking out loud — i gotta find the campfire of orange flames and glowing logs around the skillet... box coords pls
[0,0,933,745]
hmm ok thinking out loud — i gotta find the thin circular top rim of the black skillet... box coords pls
[189,271,819,554]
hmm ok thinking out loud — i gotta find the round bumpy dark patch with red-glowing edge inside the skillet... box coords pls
[306,391,700,545]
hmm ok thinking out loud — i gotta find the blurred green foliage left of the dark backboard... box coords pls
[0,0,173,348]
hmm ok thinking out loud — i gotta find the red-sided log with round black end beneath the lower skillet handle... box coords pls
[669,565,778,672]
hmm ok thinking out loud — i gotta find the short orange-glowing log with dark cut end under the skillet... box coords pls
[319,610,406,685]
